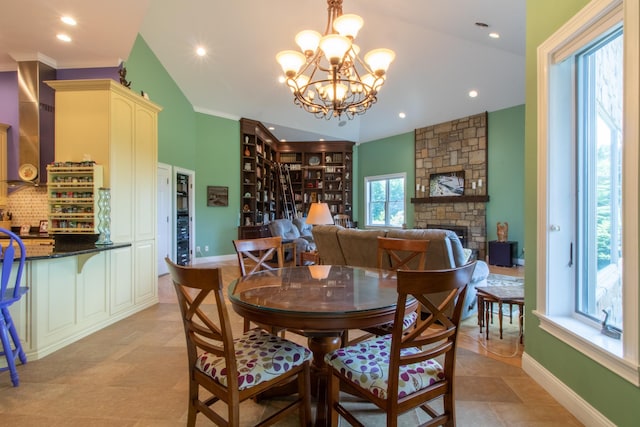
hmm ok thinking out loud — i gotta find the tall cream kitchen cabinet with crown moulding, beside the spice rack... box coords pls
[47,79,161,306]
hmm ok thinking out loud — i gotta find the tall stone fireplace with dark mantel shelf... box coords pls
[411,113,489,259]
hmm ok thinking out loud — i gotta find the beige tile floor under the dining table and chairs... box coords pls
[0,263,580,427]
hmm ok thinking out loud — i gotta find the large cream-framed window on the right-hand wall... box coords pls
[534,0,640,385]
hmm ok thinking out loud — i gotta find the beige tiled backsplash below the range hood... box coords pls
[7,187,48,227]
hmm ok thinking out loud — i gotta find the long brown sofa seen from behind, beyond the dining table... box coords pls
[312,225,489,319]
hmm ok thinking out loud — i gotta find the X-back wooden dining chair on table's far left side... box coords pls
[233,237,284,336]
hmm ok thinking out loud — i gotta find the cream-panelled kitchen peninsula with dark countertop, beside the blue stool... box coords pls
[6,234,158,360]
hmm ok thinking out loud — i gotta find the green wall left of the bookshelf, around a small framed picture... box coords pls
[125,36,240,257]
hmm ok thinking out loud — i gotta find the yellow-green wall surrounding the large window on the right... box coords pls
[524,0,640,426]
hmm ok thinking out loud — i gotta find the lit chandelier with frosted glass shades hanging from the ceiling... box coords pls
[276,0,395,119]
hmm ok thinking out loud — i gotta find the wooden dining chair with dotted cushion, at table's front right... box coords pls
[325,261,476,427]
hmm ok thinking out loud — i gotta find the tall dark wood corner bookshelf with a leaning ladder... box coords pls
[238,119,354,238]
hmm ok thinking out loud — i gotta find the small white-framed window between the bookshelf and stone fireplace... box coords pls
[364,173,406,227]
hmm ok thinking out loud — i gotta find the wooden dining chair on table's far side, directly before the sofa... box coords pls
[350,236,429,344]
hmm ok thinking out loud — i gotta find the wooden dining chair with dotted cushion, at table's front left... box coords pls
[165,258,312,426]
